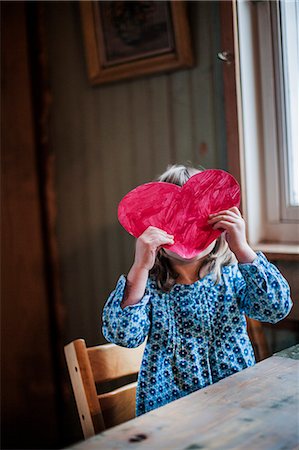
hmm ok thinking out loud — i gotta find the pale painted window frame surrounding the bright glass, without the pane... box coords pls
[234,0,299,255]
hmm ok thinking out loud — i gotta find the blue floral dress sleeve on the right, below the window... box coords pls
[235,252,292,323]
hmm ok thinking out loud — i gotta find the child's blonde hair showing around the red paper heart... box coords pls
[150,165,236,292]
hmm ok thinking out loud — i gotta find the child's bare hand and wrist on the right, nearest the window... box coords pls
[208,206,256,263]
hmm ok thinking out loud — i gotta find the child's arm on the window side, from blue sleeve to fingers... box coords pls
[209,207,292,323]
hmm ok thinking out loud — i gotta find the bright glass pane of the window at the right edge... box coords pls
[270,1,299,221]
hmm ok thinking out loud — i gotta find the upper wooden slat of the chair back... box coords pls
[87,343,145,383]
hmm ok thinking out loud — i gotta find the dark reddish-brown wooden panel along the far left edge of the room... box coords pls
[1,2,58,449]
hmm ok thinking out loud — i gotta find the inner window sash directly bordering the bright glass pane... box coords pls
[256,1,299,223]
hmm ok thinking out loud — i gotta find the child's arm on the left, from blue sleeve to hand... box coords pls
[103,227,173,347]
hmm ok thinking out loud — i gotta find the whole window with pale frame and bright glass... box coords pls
[237,0,299,253]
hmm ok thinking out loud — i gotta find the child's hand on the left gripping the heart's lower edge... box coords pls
[134,226,174,271]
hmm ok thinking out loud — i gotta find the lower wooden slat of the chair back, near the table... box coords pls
[98,382,137,428]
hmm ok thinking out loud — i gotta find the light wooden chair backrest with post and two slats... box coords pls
[64,339,145,439]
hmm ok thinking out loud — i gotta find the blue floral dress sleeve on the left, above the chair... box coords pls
[102,275,151,348]
